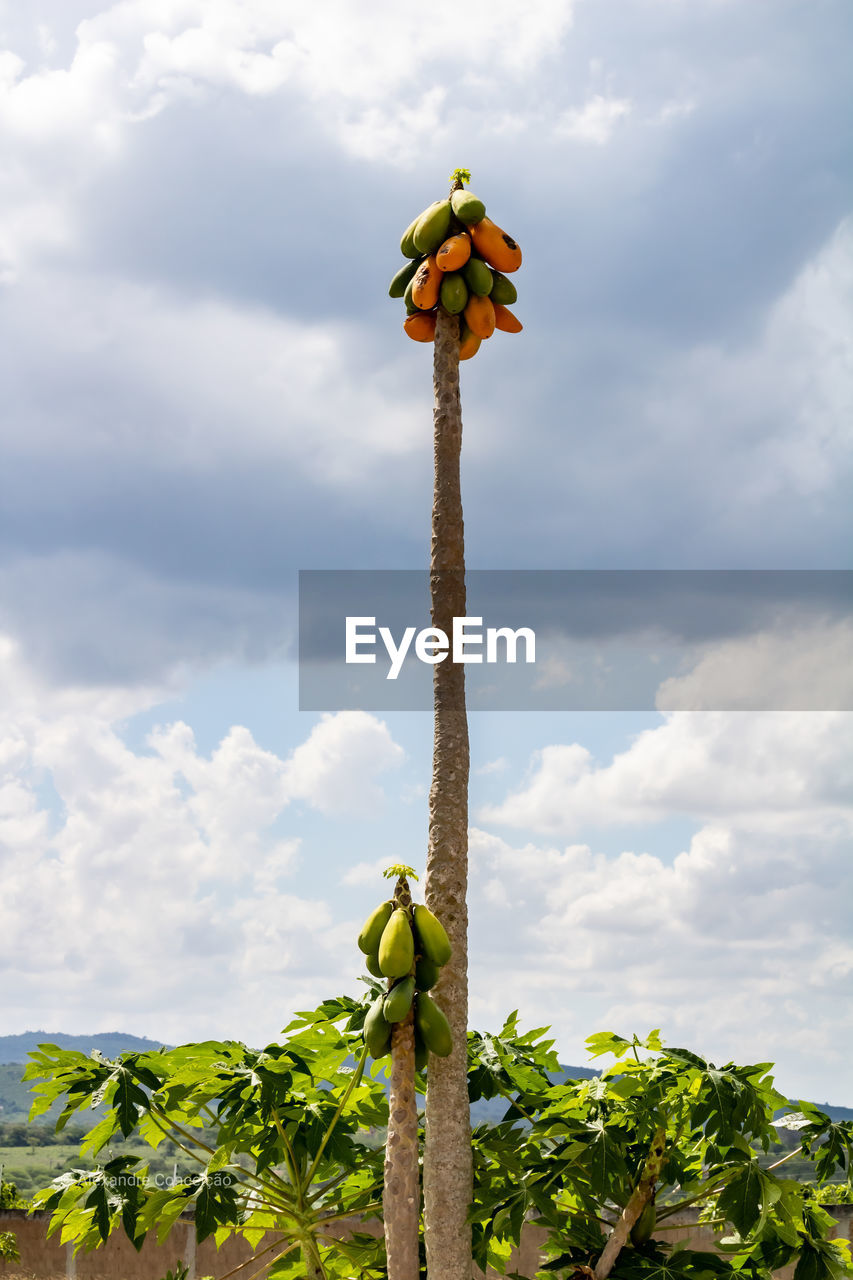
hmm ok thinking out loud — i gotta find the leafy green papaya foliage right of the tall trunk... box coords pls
[469,1015,853,1280]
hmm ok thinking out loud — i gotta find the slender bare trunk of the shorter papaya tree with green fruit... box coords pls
[382,877,420,1280]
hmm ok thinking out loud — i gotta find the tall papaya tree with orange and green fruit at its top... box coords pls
[389,169,521,1280]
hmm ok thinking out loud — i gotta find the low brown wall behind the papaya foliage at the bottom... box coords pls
[0,1204,853,1280]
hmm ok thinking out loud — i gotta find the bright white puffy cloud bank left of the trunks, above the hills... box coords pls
[0,641,402,1038]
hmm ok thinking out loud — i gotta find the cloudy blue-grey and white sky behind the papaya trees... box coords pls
[0,0,853,1105]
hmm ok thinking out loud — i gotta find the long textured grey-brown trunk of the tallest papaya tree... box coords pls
[424,307,473,1280]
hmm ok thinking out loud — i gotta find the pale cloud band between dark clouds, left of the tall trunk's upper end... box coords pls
[0,274,425,485]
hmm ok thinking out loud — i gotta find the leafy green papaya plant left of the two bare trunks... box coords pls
[24,997,388,1280]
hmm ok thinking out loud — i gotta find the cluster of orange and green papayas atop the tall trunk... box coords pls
[388,180,521,360]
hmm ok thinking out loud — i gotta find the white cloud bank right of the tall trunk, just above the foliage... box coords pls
[471,819,853,1103]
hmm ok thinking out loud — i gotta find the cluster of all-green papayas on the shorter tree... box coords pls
[359,901,453,1071]
